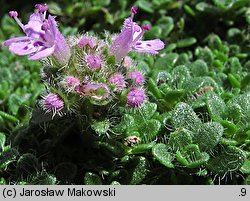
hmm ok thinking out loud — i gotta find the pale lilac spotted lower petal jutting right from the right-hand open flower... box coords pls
[132,39,165,54]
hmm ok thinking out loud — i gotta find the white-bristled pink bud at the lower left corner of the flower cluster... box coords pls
[40,93,64,117]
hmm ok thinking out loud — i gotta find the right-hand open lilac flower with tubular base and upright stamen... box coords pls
[110,7,165,62]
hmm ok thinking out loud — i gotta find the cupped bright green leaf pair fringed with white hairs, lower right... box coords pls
[176,144,209,168]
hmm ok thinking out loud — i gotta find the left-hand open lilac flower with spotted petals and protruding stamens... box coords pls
[3,4,70,65]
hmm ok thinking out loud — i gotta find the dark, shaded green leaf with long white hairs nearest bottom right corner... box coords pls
[207,146,245,176]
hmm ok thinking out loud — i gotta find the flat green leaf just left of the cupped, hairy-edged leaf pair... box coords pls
[152,143,174,168]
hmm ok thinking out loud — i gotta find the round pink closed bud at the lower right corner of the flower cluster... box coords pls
[127,88,146,107]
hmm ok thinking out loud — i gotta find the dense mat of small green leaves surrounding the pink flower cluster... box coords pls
[0,0,250,184]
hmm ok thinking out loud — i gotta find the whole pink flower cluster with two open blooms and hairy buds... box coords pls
[3,4,164,117]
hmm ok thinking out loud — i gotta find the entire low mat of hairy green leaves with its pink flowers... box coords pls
[0,0,250,185]
